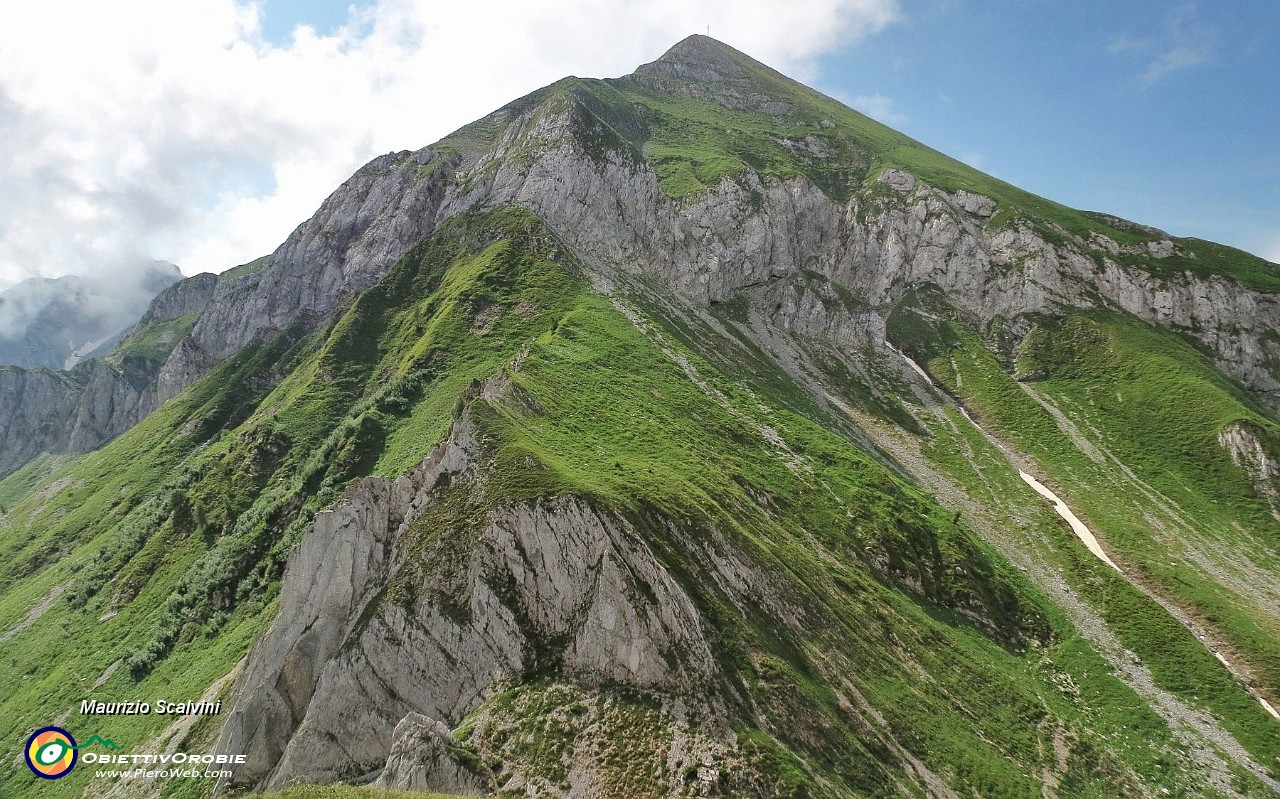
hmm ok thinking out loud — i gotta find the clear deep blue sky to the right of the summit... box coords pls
[818,0,1280,260]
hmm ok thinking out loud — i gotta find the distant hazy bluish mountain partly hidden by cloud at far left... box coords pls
[0,261,182,369]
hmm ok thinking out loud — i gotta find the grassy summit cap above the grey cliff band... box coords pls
[430,36,1280,293]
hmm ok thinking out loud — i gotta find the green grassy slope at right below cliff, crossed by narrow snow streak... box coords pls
[629,284,1280,788]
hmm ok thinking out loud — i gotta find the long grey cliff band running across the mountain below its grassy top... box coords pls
[152,54,1280,425]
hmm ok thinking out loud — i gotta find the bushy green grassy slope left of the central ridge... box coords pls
[0,211,564,795]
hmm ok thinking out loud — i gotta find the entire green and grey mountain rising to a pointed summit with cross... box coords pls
[0,36,1280,799]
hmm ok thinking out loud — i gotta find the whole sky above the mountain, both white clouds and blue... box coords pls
[0,0,1280,287]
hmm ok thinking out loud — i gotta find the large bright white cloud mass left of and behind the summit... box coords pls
[0,0,899,283]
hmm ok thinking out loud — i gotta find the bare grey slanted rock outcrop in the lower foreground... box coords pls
[219,417,717,787]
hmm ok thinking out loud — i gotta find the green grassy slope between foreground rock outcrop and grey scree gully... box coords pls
[453,279,1239,795]
